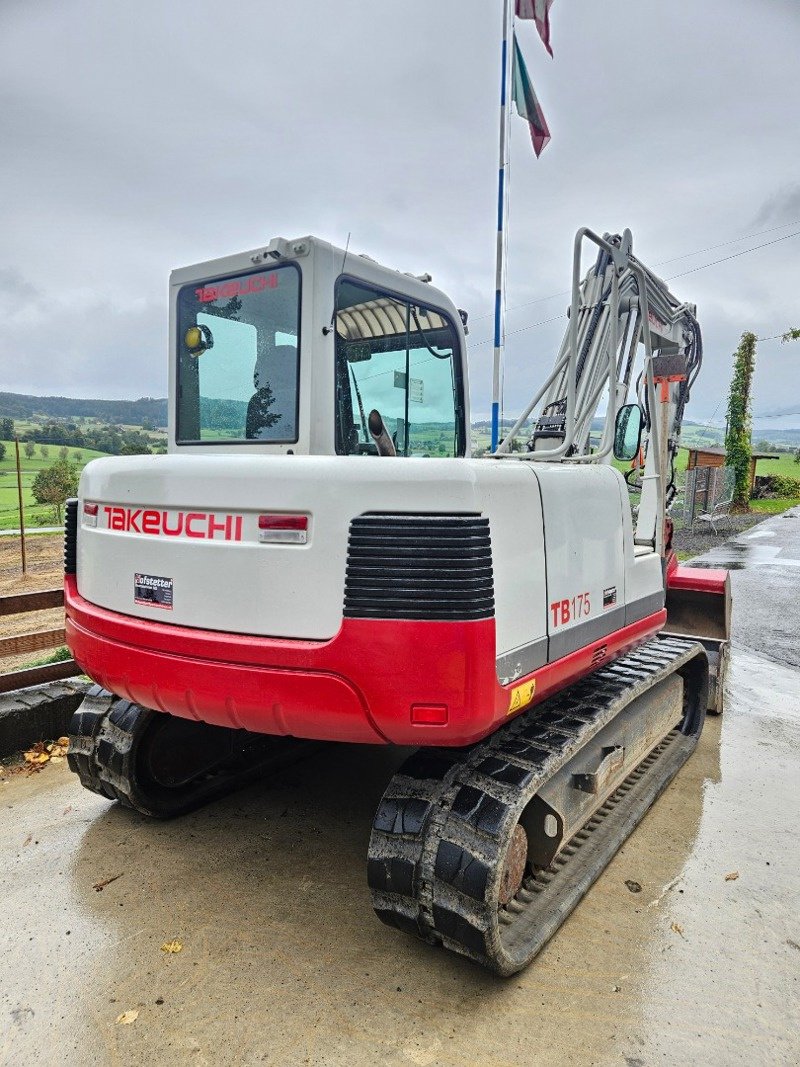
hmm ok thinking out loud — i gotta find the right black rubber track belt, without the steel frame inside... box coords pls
[368,638,708,975]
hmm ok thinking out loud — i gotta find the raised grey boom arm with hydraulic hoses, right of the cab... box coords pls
[495,228,702,552]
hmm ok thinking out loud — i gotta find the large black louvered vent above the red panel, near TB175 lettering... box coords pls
[345,514,495,621]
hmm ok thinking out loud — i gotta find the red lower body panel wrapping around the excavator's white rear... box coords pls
[65,575,666,745]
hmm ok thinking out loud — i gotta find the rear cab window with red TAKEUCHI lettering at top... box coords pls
[176,265,300,444]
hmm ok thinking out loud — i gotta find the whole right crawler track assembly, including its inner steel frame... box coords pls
[368,639,708,975]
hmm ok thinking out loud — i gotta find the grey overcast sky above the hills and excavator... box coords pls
[0,0,800,424]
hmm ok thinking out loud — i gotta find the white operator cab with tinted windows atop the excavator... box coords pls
[170,238,468,458]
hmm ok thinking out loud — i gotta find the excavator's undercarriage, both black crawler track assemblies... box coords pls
[69,637,708,975]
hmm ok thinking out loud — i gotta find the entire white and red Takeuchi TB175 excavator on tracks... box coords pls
[65,229,730,975]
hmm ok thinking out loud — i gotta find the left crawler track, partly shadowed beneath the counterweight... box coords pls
[67,686,315,818]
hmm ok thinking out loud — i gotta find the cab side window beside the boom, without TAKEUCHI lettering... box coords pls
[336,278,464,457]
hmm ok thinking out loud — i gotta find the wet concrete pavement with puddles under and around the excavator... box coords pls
[0,519,800,1067]
